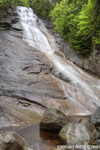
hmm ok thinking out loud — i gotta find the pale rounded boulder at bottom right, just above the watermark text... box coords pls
[59,123,95,144]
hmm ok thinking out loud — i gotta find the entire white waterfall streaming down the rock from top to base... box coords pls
[17,7,100,115]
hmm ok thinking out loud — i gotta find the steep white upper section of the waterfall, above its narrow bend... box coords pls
[17,6,54,53]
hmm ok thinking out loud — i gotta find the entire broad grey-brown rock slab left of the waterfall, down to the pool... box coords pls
[0,26,66,127]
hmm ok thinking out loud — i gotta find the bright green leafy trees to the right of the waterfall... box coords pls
[50,0,100,56]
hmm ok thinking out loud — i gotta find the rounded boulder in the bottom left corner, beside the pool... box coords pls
[0,132,32,150]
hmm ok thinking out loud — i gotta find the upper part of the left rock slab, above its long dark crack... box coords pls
[0,31,64,101]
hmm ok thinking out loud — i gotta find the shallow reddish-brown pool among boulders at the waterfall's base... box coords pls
[0,116,89,150]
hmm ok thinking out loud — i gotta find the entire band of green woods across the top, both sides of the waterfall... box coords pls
[0,0,100,56]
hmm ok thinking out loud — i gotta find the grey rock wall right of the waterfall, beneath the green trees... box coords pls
[57,38,100,76]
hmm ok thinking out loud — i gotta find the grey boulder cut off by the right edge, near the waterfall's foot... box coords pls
[90,106,100,126]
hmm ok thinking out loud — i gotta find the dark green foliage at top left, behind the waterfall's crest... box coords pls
[0,0,54,20]
